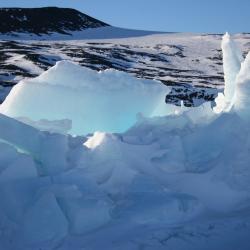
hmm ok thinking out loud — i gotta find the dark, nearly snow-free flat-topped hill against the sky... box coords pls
[0,7,109,35]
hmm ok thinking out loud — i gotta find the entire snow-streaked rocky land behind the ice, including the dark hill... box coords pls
[0,7,250,106]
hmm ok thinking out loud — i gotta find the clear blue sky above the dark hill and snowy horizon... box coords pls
[0,0,250,33]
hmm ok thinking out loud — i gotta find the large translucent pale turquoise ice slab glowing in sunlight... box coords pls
[0,61,170,135]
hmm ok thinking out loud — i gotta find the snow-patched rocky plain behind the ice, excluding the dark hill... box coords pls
[0,27,250,106]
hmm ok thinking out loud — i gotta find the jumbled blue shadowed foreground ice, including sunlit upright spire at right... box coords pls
[0,33,250,250]
